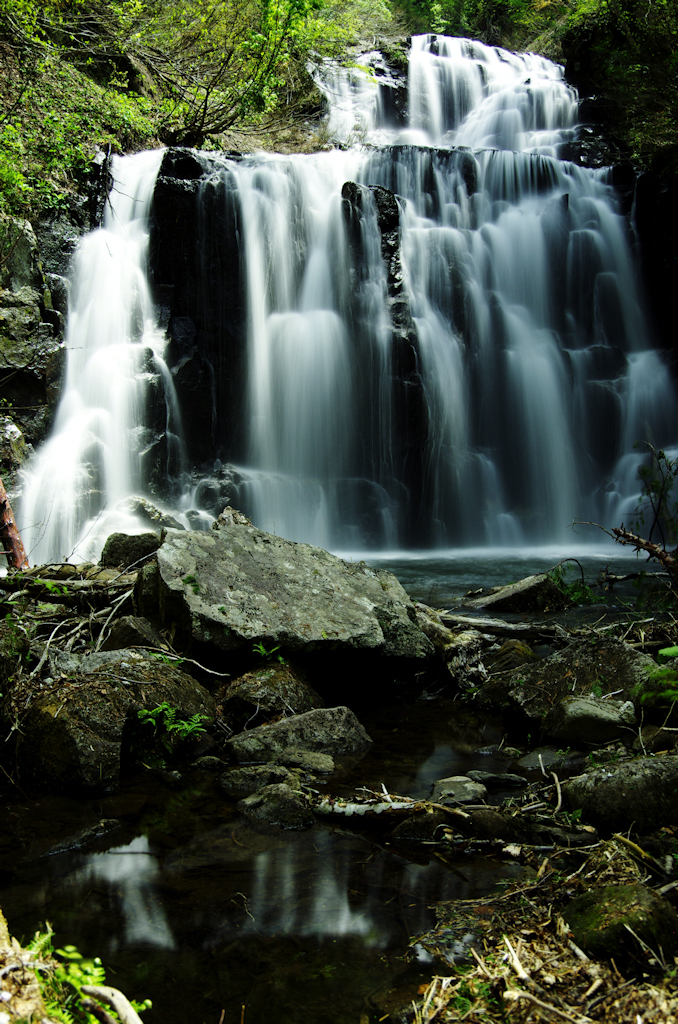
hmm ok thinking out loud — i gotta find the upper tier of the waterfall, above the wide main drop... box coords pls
[316,36,578,156]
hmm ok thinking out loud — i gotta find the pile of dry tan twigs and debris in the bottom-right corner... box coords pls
[413,838,678,1024]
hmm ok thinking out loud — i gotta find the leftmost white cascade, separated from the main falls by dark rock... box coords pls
[20,151,180,562]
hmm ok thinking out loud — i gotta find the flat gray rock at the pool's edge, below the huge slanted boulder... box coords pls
[228,708,372,764]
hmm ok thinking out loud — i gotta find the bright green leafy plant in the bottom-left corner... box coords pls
[27,925,152,1024]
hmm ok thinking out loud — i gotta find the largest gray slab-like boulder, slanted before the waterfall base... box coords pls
[137,514,434,659]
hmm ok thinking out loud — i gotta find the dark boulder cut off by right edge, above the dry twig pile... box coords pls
[563,756,678,835]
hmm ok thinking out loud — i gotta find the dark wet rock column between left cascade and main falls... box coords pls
[150,150,246,468]
